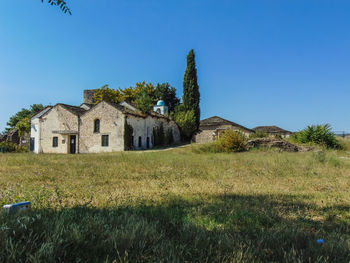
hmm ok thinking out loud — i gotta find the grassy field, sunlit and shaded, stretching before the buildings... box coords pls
[0,146,350,262]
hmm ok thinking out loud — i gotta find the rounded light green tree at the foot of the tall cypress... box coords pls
[174,110,197,140]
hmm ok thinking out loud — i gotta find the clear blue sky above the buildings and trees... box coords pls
[0,0,350,131]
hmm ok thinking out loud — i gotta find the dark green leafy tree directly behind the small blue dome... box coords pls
[154,82,180,112]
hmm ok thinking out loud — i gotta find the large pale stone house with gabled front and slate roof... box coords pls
[31,90,180,154]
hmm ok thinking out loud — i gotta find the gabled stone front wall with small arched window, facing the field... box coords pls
[80,102,124,153]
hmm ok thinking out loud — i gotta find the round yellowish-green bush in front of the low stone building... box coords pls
[216,130,246,152]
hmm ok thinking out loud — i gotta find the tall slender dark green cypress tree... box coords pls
[182,49,200,129]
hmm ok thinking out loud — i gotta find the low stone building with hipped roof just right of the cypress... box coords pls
[193,116,254,143]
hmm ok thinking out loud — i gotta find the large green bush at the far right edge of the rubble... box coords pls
[292,124,342,149]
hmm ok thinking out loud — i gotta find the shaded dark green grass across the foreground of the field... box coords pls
[0,195,350,262]
